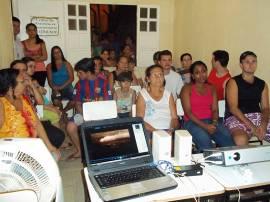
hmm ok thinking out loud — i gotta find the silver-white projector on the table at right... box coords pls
[203,145,270,166]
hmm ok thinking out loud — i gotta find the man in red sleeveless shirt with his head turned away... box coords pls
[208,50,231,100]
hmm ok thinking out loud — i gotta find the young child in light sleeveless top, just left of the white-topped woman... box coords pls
[113,72,136,118]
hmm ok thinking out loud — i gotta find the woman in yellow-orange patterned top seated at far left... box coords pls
[0,69,60,158]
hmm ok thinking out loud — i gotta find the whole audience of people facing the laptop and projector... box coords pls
[5,17,270,159]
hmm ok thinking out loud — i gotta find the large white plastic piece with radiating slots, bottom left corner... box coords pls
[0,138,64,202]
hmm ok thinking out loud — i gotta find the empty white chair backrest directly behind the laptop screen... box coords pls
[83,100,117,121]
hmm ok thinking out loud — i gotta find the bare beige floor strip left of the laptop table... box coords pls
[58,149,84,202]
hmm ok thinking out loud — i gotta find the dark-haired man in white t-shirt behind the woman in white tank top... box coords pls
[158,50,184,100]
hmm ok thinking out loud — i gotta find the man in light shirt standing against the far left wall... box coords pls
[12,17,24,60]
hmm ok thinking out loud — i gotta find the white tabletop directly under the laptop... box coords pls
[84,168,224,202]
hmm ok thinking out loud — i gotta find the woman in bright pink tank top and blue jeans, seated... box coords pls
[180,61,234,152]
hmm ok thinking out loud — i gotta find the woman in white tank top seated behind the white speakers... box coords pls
[136,65,179,137]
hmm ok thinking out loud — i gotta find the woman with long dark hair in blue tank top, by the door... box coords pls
[47,46,74,111]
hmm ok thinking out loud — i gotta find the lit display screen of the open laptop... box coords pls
[83,122,149,164]
